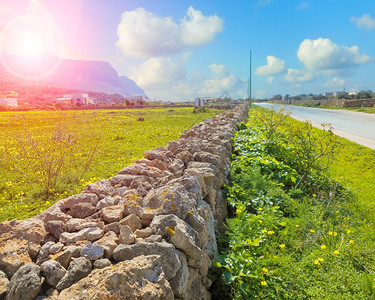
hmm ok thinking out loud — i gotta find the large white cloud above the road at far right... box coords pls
[297,38,372,70]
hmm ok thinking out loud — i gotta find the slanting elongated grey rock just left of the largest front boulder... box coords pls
[56,257,91,291]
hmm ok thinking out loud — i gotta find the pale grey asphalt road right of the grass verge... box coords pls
[256,103,375,149]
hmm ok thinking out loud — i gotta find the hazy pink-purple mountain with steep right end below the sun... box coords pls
[0,54,146,98]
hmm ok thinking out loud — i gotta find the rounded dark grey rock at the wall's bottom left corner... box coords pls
[6,263,42,300]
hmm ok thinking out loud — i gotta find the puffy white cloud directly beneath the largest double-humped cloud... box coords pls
[131,55,188,90]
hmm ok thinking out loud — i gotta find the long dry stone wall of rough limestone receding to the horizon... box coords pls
[0,105,247,300]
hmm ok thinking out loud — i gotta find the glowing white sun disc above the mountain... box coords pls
[15,31,46,56]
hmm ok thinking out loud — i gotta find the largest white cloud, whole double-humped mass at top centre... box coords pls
[116,7,224,58]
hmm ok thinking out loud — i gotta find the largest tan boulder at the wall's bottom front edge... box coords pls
[57,255,174,300]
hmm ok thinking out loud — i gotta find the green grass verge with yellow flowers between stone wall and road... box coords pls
[213,106,375,299]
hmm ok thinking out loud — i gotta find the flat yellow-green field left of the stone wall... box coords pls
[0,108,220,222]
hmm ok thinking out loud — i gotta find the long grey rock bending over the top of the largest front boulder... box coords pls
[113,242,181,280]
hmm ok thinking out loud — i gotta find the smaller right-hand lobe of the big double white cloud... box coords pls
[180,6,224,46]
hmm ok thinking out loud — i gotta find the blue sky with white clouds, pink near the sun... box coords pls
[0,0,375,101]
